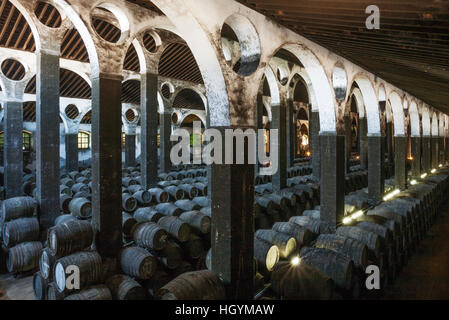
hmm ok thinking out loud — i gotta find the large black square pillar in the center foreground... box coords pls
[209,127,254,300]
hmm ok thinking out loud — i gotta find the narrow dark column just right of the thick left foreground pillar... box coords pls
[140,73,159,190]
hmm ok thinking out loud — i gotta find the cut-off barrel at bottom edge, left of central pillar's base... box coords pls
[156,270,226,300]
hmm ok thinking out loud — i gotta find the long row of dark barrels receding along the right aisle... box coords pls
[270,169,449,299]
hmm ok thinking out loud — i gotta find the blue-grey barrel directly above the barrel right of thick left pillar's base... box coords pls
[133,222,168,250]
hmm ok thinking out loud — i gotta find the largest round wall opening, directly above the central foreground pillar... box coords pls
[221,14,260,76]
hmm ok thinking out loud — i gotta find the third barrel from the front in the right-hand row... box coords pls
[315,234,368,270]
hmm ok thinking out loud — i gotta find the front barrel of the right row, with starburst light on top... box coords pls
[271,261,334,300]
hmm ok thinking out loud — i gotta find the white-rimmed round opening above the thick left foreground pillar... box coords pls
[91,3,129,43]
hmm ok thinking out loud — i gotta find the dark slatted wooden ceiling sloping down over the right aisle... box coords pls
[238,0,449,113]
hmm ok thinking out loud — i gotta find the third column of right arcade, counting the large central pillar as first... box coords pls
[368,134,385,203]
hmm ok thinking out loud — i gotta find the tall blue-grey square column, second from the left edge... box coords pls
[36,49,60,229]
